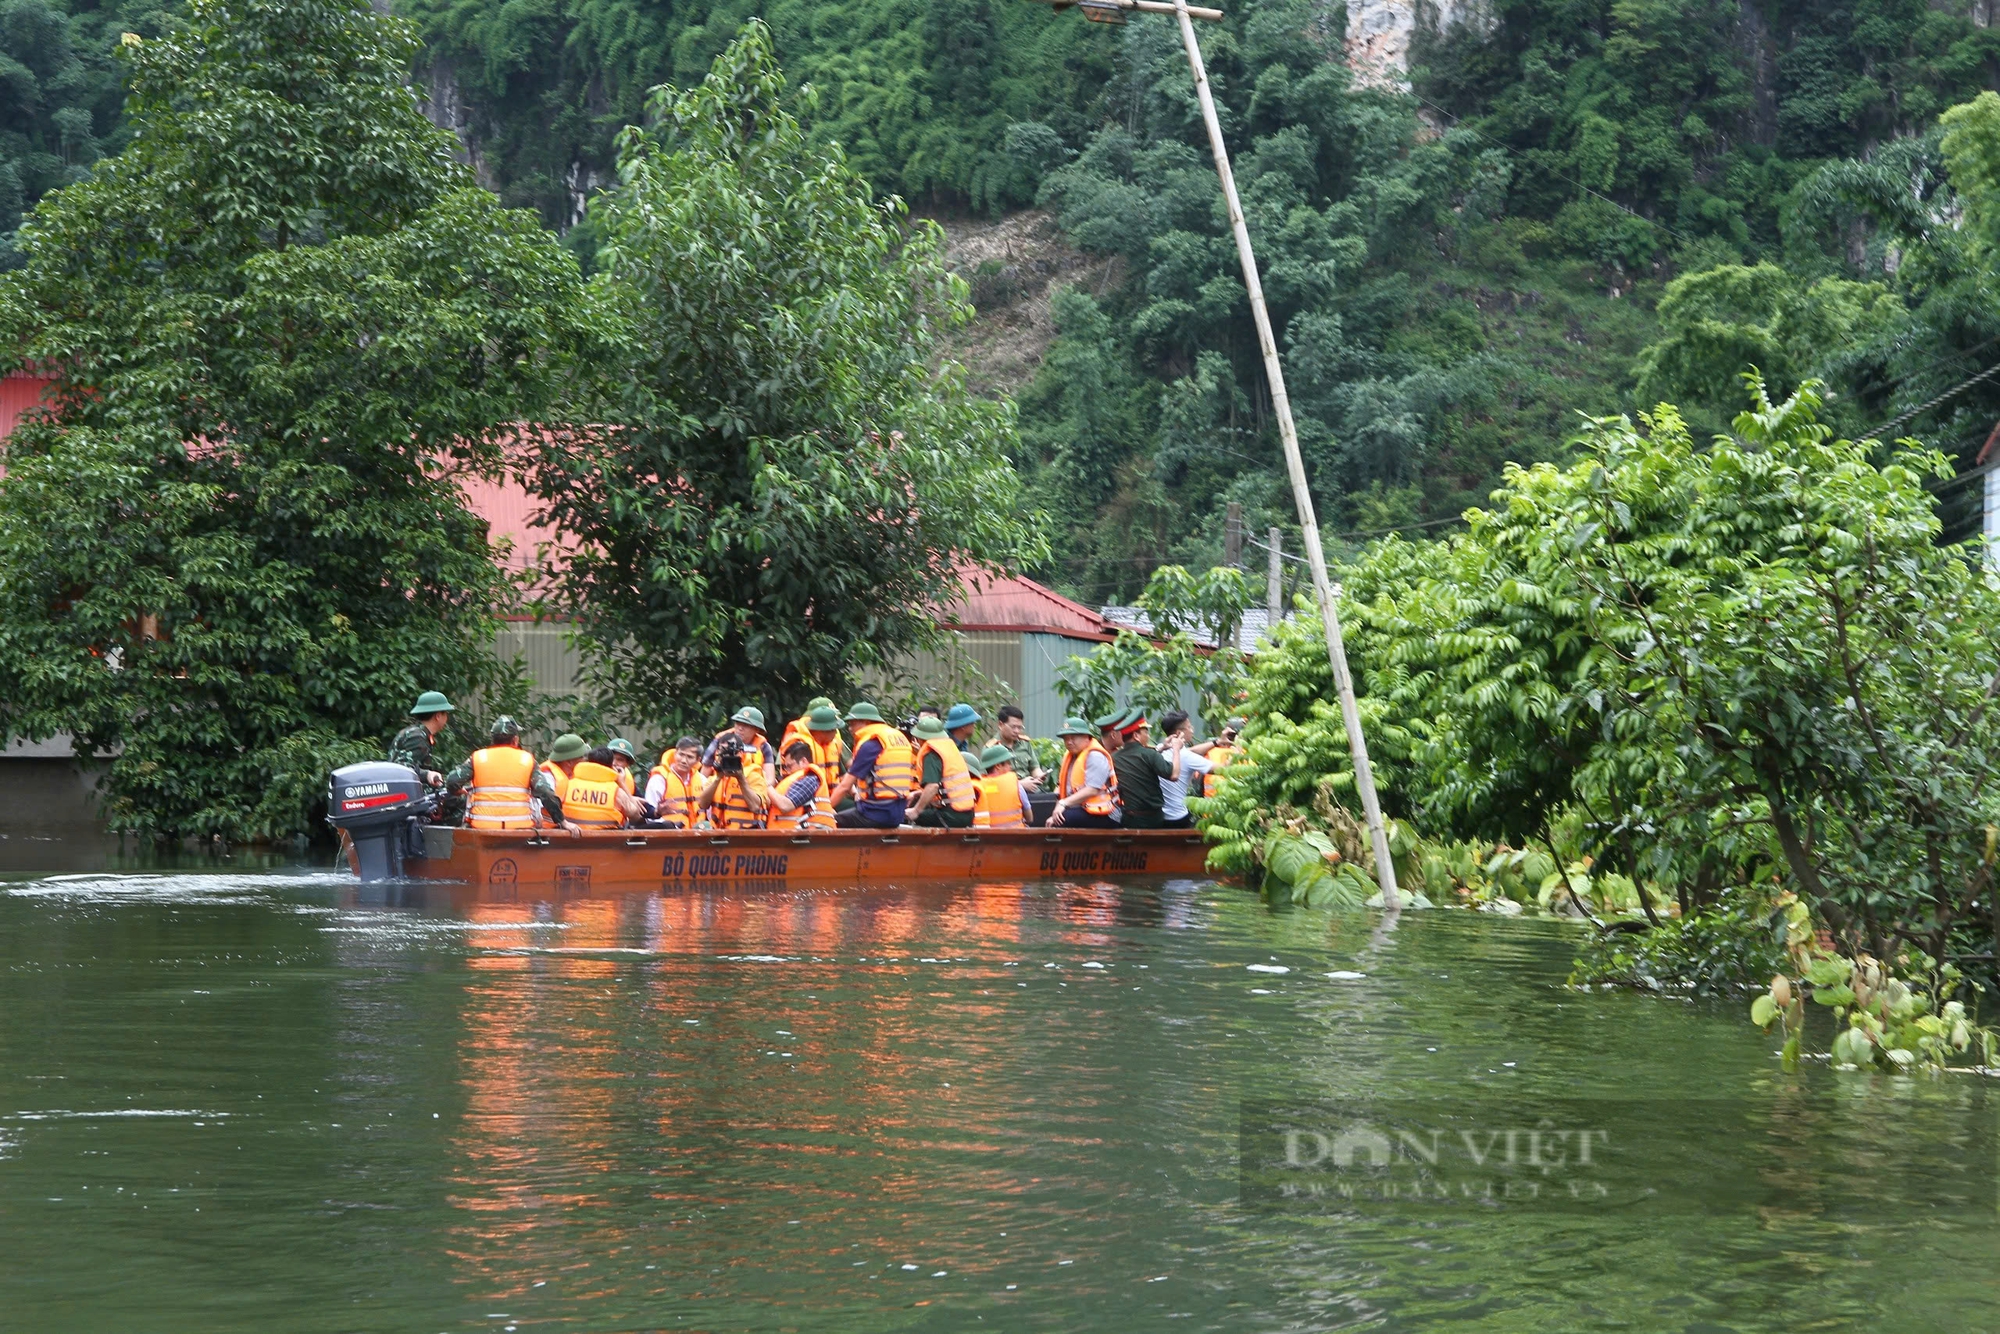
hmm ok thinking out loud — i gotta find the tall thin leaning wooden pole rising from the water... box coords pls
[1168,0,1402,910]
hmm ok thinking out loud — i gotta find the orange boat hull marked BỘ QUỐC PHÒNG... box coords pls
[382,826,1208,894]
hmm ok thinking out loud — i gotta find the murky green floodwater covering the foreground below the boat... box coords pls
[0,868,2000,1332]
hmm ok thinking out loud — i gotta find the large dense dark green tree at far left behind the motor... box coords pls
[0,0,582,838]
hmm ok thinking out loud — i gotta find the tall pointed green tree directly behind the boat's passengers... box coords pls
[534,24,1044,740]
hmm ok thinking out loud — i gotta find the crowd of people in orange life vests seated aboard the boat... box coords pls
[388,690,1242,832]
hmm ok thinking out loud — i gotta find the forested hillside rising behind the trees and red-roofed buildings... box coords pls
[11,0,2000,600]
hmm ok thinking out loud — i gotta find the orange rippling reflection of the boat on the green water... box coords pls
[434,884,1118,1298]
